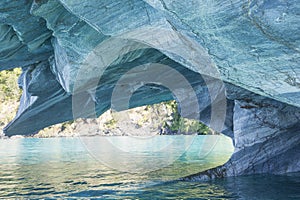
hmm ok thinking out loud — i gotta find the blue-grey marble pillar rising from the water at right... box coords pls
[184,96,300,180]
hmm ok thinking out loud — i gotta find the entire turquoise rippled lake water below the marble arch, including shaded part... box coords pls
[0,136,300,199]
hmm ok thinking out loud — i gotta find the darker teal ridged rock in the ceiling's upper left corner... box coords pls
[0,0,53,70]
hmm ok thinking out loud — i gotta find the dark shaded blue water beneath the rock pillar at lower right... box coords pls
[137,173,300,200]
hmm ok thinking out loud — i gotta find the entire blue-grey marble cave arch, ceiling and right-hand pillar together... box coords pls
[0,0,300,176]
